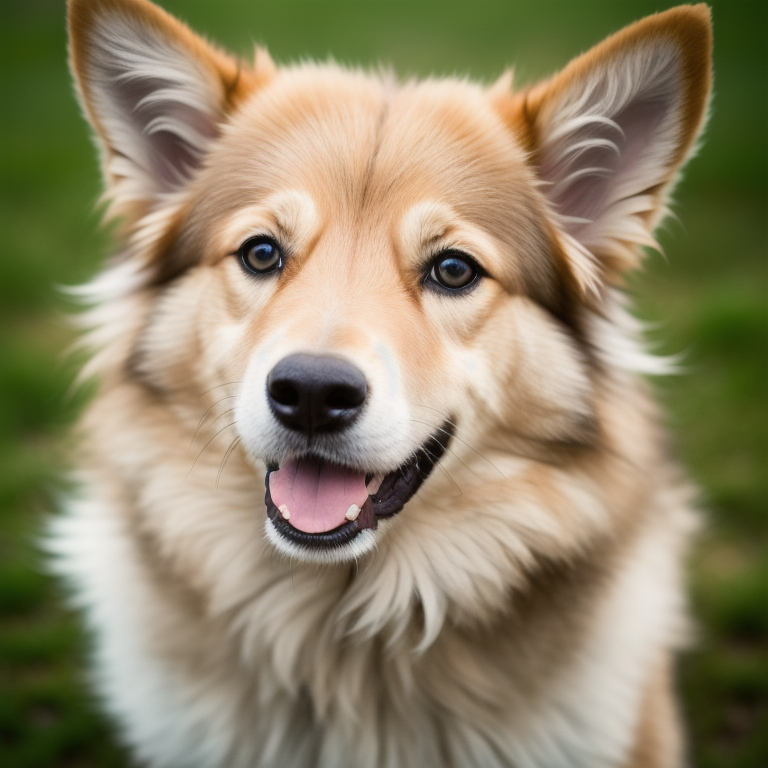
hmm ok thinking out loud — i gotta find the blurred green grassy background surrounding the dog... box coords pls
[0,0,768,768]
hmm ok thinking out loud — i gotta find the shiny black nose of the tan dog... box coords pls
[267,353,368,437]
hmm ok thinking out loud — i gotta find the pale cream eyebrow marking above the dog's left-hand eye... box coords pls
[223,189,320,251]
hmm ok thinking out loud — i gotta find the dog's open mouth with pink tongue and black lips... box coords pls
[265,422,453,550]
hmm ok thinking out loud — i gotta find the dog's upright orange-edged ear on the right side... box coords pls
[495,5,712,282]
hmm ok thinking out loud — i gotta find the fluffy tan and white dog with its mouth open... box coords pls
[51,0,711,768]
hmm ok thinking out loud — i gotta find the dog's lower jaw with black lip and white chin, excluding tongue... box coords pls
[264,422,454,563]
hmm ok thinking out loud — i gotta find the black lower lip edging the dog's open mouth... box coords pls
[264,421,455,550]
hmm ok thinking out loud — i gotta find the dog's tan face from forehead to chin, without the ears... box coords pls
[130,68,591,557]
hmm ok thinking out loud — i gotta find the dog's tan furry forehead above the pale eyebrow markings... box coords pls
[207,66,534,232]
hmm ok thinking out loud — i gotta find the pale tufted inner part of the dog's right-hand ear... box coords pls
[531,38,687,281]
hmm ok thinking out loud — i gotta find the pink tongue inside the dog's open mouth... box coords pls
[269,458,368,533]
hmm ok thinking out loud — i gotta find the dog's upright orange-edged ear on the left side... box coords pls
[69,0,269,218]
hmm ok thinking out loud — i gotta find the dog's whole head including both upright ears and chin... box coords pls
[70,0,710,561]
